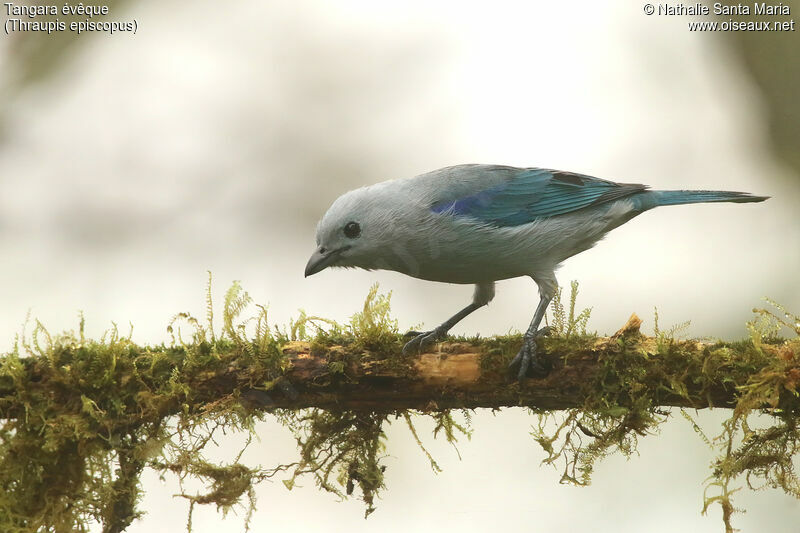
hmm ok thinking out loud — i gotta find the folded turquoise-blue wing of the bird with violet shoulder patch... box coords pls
[431,167,647,226]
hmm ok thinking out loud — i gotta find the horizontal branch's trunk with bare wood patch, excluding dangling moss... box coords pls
[0,315,780,414]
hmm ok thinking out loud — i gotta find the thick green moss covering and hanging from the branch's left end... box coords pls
[0,276,283,531]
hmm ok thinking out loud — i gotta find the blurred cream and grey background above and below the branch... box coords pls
[0,0,800,532]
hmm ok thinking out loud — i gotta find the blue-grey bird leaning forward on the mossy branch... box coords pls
[305,164,769,381]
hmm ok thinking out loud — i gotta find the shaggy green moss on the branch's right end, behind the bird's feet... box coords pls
[532,296,800,531]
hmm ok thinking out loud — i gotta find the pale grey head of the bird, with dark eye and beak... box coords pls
[305,188,389,277]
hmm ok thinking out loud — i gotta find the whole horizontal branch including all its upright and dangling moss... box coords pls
[0,278,800,532]
